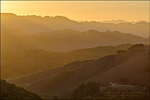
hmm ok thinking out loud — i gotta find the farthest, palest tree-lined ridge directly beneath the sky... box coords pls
[1,13,149,37]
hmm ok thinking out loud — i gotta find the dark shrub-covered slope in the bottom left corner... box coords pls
[0,80,44,100]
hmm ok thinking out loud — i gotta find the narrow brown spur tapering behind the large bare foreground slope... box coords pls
[10,60,93,86]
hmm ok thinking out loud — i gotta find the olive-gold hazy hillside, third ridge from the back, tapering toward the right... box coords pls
[1,44,131,79]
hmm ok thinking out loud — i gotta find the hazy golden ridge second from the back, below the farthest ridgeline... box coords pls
[2,29,149,53]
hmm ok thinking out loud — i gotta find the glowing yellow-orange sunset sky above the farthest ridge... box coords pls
[1,1,149,21]
